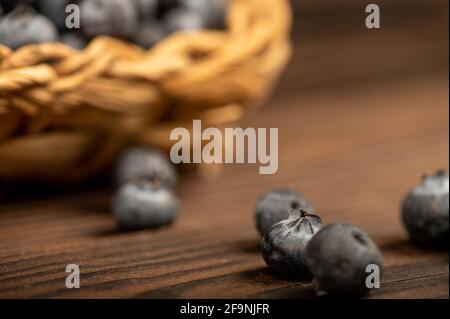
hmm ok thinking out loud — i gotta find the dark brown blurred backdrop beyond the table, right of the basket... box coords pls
[277,0,448,95]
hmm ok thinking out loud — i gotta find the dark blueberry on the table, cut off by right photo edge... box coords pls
[402,171,449,248]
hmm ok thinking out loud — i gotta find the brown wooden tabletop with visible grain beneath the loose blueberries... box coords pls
[0,76,449,298]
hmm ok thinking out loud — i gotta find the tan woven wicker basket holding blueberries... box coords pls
[0,0,291,181]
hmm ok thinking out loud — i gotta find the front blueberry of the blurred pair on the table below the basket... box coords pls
[113,179,179,230]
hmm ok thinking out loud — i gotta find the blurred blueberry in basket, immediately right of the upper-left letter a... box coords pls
[80,0,139,39]
